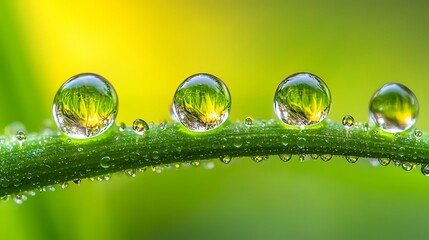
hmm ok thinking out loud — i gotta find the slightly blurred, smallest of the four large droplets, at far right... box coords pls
[369,83,419,133]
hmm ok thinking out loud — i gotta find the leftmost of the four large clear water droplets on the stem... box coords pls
[52,73,118,138]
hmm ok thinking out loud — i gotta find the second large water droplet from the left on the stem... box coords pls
[173,73,231,132]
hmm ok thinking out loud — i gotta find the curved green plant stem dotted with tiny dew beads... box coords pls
[0,120,429,196]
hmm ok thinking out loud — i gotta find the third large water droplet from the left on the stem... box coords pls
[274,73,331,127]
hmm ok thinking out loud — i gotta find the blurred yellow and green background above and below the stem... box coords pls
[0,0,429,239]
